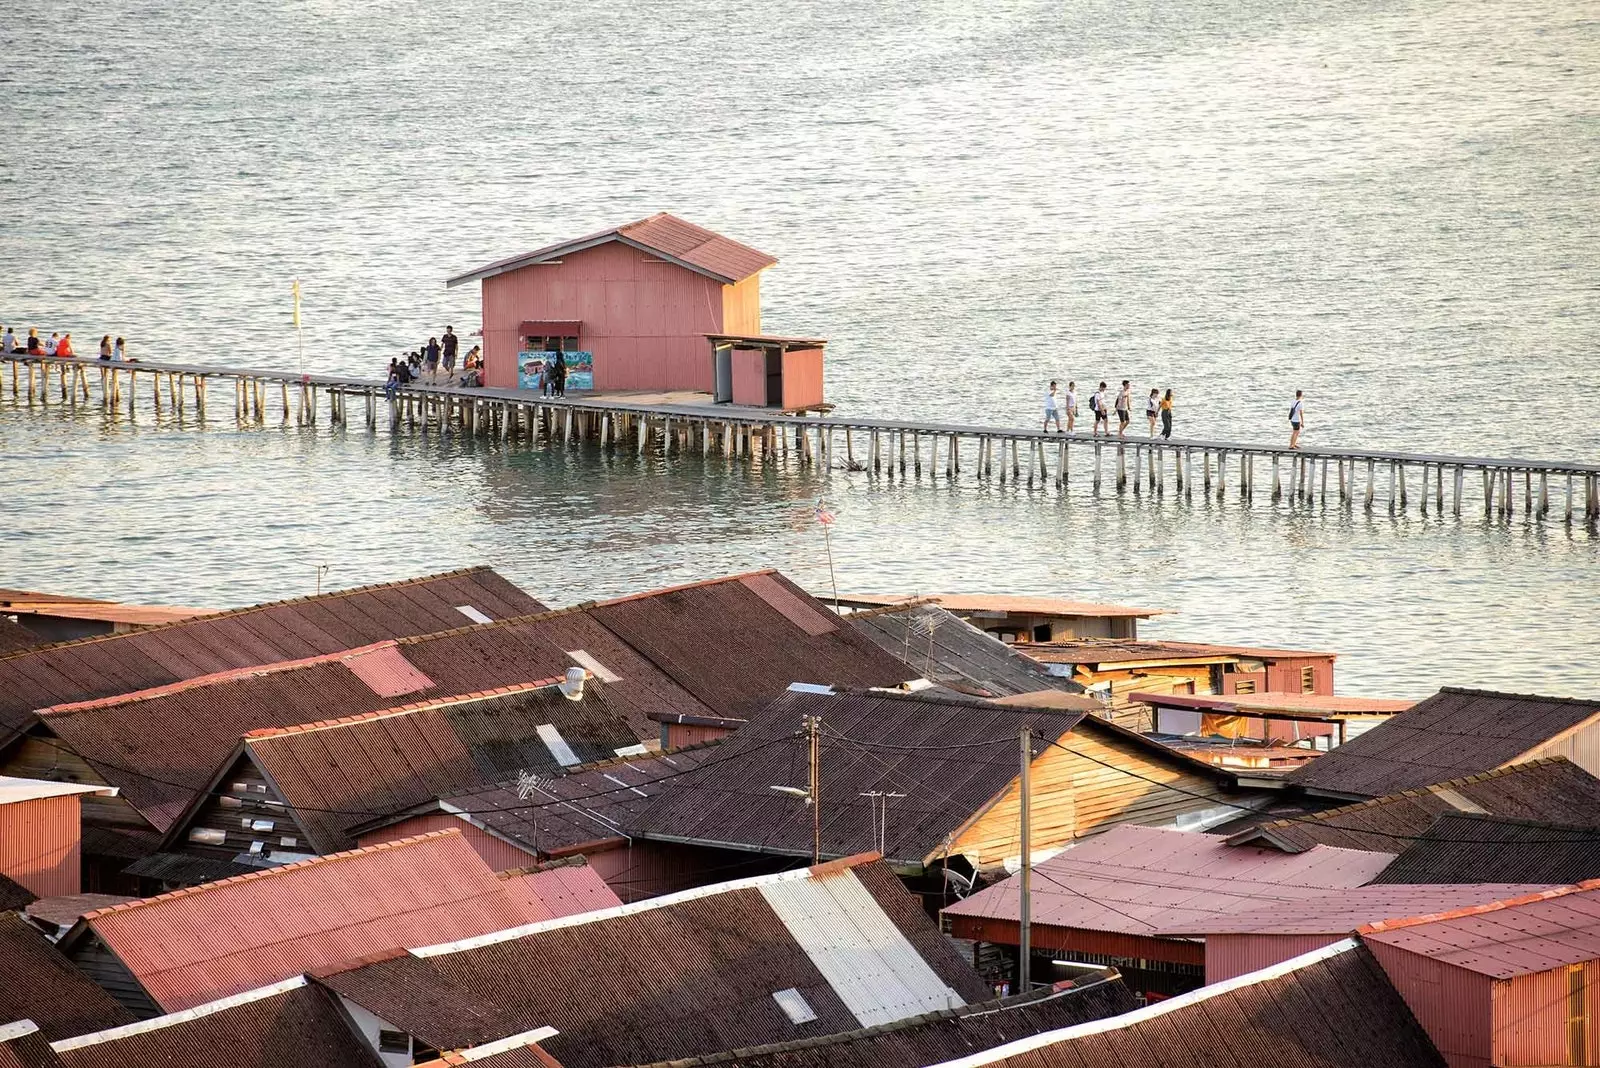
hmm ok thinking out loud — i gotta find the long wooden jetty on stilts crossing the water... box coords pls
[0,353,1600,526]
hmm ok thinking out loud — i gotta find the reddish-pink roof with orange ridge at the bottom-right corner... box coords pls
[1360,879,1600,978]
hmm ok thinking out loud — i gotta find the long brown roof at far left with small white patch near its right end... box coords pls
[0,568,544,737]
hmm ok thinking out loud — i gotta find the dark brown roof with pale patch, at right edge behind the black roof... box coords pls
[1227,756,1600,852]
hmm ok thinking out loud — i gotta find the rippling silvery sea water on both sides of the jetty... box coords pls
[0,0,1600,695]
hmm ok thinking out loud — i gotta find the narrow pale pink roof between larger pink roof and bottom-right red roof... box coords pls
[1160,883,1552,938]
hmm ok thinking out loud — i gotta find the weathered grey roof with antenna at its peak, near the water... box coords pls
[845,603,1083,697]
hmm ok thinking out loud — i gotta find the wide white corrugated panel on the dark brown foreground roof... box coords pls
[760,870,966,1026]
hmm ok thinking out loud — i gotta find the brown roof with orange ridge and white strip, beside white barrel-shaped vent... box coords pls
[187,679,648,852]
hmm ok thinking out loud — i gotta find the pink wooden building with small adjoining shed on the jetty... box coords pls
[446,213,824,411]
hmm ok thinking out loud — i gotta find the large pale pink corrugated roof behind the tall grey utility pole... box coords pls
[944,825,1394,935]
